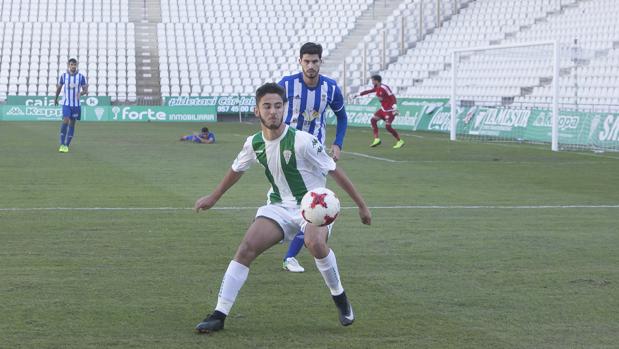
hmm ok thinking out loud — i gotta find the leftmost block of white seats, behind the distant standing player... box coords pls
[0,0,136,102]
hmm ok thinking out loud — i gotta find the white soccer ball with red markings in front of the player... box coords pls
[301,188,340,227]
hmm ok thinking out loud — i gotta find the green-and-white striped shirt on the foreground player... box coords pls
[232,125,335,206]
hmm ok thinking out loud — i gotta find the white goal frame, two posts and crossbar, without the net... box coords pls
[449,40,561,151]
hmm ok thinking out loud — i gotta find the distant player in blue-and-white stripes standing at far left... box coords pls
[54,58,88,153]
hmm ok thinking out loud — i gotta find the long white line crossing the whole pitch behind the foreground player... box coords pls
[0,204,619,212]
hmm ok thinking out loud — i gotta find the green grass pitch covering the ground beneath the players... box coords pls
[0,122,619,348]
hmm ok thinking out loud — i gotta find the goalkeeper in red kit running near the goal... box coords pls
[359,75,404,149]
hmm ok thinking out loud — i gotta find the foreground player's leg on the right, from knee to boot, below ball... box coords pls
[305,224,355,326]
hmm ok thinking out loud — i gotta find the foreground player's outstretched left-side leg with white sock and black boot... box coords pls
[195,210,284,333]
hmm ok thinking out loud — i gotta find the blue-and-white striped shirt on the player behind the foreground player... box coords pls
[278,72,344,144]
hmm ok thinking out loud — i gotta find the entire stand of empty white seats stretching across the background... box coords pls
[0,0,619,109]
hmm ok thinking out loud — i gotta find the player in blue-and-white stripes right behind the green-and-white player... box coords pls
[279,42,348,273]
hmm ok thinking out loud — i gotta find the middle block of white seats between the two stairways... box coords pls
[157,0,372,96]
